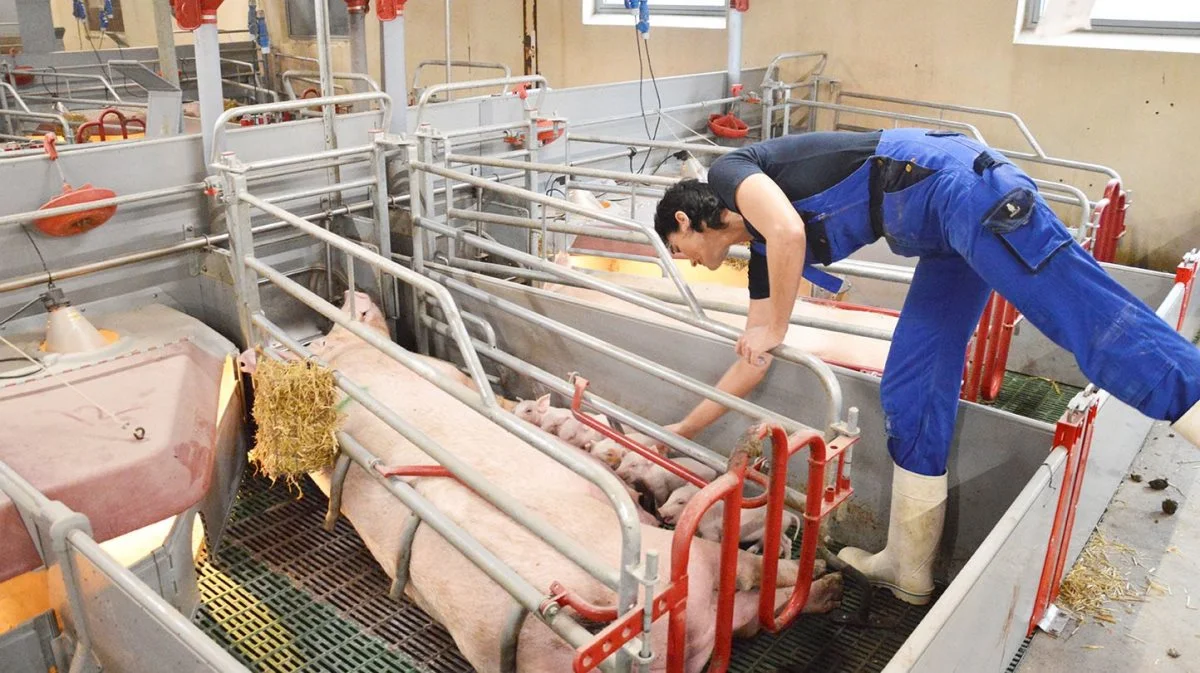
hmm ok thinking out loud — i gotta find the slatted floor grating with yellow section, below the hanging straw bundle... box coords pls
[196,476,472,673]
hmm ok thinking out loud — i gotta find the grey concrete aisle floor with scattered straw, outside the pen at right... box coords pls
[1018,423,1200,673]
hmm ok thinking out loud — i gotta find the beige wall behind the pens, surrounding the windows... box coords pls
[82,0,1200,270]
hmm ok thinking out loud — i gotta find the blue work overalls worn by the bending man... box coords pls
[750,128,1200,476]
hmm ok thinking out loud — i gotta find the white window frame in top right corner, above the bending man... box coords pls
[1013,0,1200,53]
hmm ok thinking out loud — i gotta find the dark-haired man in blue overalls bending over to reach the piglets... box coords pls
[654,128,1200,605]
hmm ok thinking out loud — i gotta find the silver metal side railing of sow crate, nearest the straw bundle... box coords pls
[216,142,641,669]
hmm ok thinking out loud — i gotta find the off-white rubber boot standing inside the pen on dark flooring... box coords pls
[838,460,945,606]
